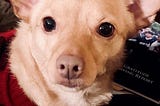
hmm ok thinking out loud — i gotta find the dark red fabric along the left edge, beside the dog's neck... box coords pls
[0,30,36,106]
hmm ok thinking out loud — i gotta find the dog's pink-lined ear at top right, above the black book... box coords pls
[126,0,160,29]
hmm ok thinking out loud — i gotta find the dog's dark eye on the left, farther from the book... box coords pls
[43,17,56,32]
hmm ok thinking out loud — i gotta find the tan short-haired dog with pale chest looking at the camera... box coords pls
[10,0,159,106]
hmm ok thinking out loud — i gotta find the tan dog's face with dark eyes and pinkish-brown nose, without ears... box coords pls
[17,0,134,89]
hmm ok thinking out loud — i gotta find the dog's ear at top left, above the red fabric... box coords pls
[10,0,38,21]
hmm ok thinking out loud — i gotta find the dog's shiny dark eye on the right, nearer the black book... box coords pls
[97,22,115,37]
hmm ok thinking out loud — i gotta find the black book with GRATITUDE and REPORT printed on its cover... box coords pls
[114,22,160,104]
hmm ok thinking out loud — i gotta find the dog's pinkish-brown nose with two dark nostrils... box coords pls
[56,55,84,80]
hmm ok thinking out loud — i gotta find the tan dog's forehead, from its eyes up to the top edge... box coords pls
[32,0,130,32]
